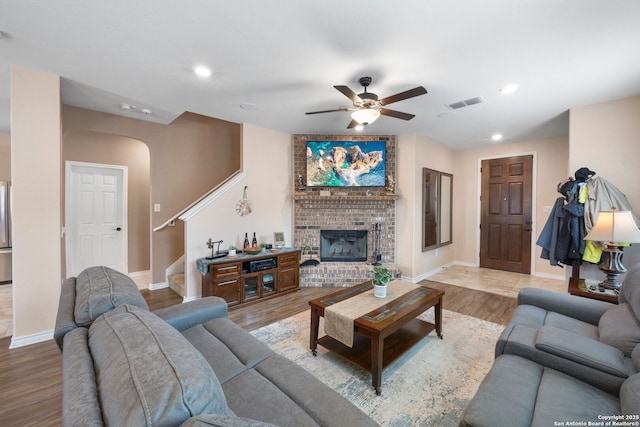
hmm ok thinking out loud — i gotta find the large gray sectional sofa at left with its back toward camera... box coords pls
[54,267,378,427]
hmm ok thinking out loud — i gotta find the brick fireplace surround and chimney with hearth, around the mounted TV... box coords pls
[293,135,398,287]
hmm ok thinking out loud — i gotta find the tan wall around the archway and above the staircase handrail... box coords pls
[63,106,240,284]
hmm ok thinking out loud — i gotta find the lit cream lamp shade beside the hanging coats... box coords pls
[584,209,640,243]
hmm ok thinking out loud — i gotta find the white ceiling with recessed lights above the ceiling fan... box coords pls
[0,0,640,149]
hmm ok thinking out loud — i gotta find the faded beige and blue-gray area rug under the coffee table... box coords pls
[251,310,504,427]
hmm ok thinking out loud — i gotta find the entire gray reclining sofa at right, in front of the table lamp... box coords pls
[460,264,640,427]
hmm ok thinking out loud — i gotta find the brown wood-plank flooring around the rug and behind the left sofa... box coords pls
[0,282,516,426]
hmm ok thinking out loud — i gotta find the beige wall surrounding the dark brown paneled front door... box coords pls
[453,138,569,277]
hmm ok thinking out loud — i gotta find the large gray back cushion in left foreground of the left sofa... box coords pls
[89,304,234,426]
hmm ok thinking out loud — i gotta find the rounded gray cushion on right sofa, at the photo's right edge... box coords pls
[598,303,640,357]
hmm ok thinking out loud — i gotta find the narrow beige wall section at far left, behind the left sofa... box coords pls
[11,65,62,346]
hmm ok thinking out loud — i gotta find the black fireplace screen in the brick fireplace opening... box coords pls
[320,230,367,262]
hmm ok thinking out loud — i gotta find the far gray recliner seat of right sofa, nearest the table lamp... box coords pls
[495,264,640,395]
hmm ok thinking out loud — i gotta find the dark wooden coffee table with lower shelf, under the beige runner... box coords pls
[309,281,444,395]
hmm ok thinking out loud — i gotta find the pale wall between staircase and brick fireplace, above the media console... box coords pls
[185,124,293,298]
